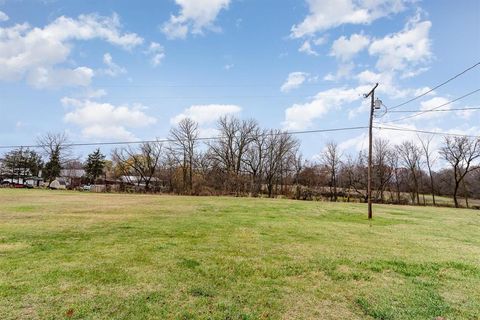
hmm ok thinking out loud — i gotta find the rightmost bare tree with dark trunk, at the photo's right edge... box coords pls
[440,137,480,208]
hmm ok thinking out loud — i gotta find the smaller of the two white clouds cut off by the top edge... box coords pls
[162,0,230,39]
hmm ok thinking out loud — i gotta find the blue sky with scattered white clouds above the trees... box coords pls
[0,0,480,159]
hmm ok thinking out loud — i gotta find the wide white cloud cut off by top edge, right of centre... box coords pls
[291,0,405,38]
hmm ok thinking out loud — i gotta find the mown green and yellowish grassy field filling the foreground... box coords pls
[0,189,480,319]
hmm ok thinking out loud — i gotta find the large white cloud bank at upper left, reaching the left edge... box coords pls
[0,14,143,87]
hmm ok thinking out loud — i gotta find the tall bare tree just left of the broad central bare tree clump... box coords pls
[169,118,198,193]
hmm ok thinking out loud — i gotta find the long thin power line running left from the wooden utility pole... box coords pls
[0,126,368,149]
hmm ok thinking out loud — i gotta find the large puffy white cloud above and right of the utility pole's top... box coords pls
[369,19,432,72]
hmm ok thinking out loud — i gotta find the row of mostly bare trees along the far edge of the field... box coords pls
[0,116,480,207]
